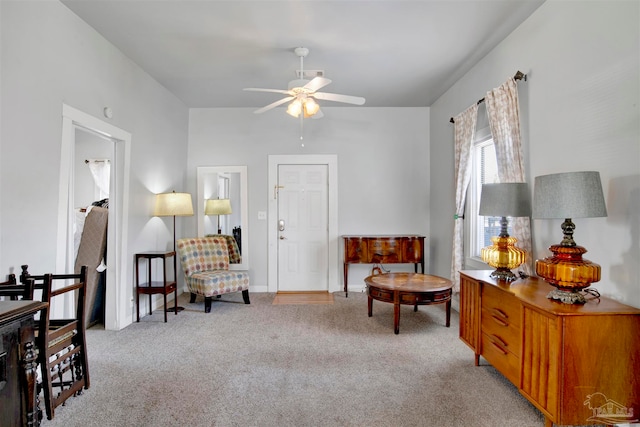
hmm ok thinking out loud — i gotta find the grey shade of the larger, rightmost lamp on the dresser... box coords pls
[533,171,607,219]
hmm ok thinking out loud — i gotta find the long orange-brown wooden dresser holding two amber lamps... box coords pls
[460,270,640,427]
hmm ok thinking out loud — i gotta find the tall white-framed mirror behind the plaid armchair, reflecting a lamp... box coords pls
[197,166,249,270]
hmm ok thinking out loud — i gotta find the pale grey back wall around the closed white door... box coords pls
[188,106,429,287]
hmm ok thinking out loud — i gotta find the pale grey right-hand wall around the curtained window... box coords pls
[430,0,640,307]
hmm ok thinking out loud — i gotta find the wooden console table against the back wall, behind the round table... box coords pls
[342,235,424,297]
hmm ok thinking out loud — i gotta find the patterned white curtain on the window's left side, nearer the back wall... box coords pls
[451,104,478,292]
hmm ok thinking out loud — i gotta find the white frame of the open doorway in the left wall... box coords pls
[56,104,132,330]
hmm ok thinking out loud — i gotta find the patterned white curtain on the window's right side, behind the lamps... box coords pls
[485,78,532,275]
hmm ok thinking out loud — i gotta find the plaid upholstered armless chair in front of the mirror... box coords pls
[177,235,250,313]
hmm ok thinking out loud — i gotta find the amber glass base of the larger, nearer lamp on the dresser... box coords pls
[536,244,600,304]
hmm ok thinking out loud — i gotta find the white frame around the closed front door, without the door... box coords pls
[267,154,340,292]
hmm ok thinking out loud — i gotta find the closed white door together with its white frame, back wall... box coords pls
[267,155,340,292]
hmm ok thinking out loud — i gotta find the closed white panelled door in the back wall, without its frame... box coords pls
[277,164,329,291]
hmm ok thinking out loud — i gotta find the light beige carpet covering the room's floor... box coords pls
[43,292,552,427]
